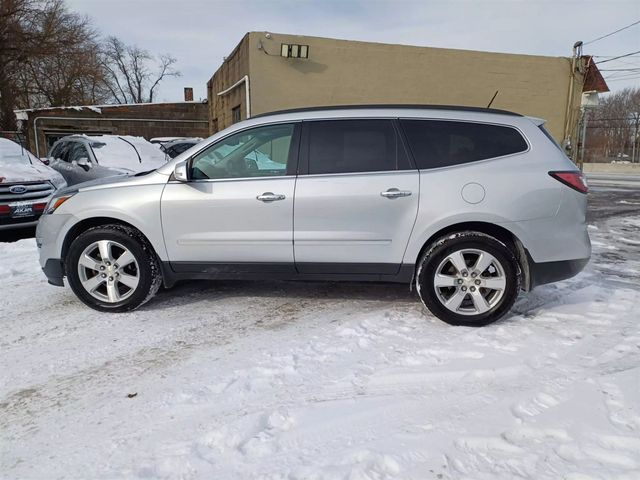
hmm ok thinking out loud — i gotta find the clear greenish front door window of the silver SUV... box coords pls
[190,124,295,179]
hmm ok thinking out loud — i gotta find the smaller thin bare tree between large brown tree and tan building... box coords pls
[102,37,180,104]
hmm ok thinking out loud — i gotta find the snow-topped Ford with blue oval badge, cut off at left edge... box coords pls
[0,137,67,230]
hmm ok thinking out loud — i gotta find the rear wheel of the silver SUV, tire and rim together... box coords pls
[416,232,520,326]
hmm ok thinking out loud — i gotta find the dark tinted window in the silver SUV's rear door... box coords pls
[307,120,410,174]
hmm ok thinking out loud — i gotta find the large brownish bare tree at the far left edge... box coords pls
[0,0,110,129]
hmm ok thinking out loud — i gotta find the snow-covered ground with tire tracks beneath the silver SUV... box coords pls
[0,190,640,480]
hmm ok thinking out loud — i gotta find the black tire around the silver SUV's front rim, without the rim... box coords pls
[65,224,162,312]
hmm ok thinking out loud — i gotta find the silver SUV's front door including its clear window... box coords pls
[161,123,299,273]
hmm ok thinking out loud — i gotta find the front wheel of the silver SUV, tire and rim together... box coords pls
[65,225,162,312]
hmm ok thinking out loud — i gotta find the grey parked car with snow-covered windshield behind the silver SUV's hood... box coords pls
[47,135,166,185]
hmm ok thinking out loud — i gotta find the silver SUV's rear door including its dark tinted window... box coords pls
[294,119,420,274]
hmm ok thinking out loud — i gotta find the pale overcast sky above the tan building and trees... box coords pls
[67,0,640,101]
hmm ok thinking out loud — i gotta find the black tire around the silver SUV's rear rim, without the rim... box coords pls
[416,231,521,327]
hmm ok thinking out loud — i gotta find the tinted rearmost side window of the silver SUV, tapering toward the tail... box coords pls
[400,120,528,169]
